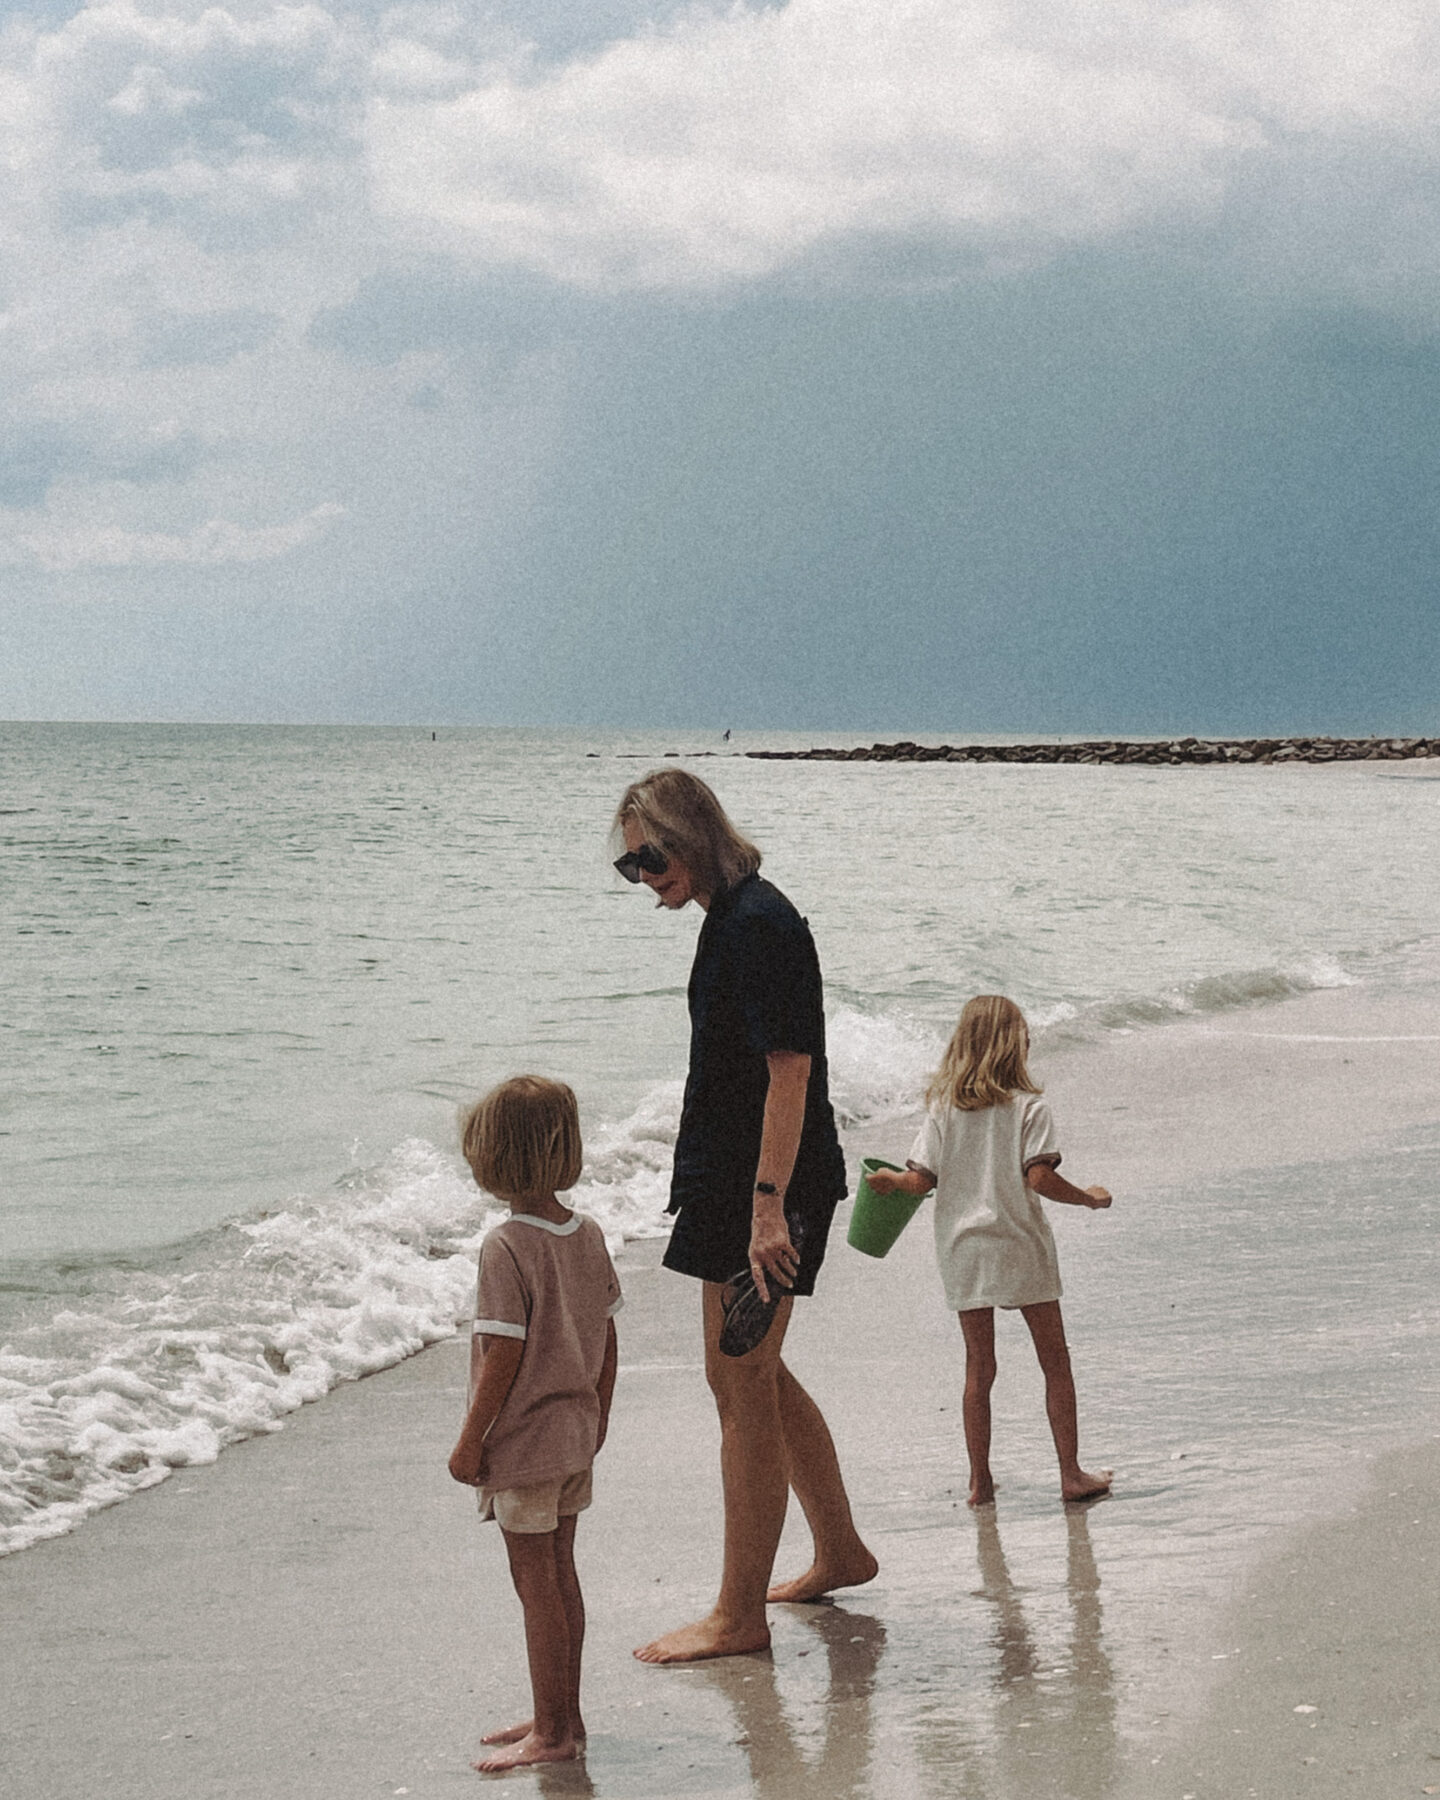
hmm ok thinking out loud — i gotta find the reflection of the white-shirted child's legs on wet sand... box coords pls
[916,1507,1116,1800]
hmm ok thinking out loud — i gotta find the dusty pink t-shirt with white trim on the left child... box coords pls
[473,1213,623,1489]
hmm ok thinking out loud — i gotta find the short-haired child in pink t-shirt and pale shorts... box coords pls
[441,1075,621,1775]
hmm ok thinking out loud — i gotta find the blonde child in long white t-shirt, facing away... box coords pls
[869,994,1111,1507]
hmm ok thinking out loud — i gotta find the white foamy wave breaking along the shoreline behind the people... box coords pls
[0,958,1354,1555]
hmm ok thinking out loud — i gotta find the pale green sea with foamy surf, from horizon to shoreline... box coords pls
[0,725,1440,1550]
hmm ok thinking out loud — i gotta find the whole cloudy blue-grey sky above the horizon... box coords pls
[0,0,1440,734]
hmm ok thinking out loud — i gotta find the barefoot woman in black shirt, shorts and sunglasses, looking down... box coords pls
[616,769,877,1663]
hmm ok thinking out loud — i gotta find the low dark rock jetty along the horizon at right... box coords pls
[743,738,1440,769]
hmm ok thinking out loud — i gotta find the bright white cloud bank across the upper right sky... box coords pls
[365,0,1440,290]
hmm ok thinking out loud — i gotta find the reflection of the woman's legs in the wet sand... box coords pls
[702,1606,886,1800]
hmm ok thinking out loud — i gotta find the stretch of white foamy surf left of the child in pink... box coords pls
[0,1139,495,1553]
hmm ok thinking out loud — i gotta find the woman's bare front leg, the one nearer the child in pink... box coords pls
[635,1282,794,1663]
